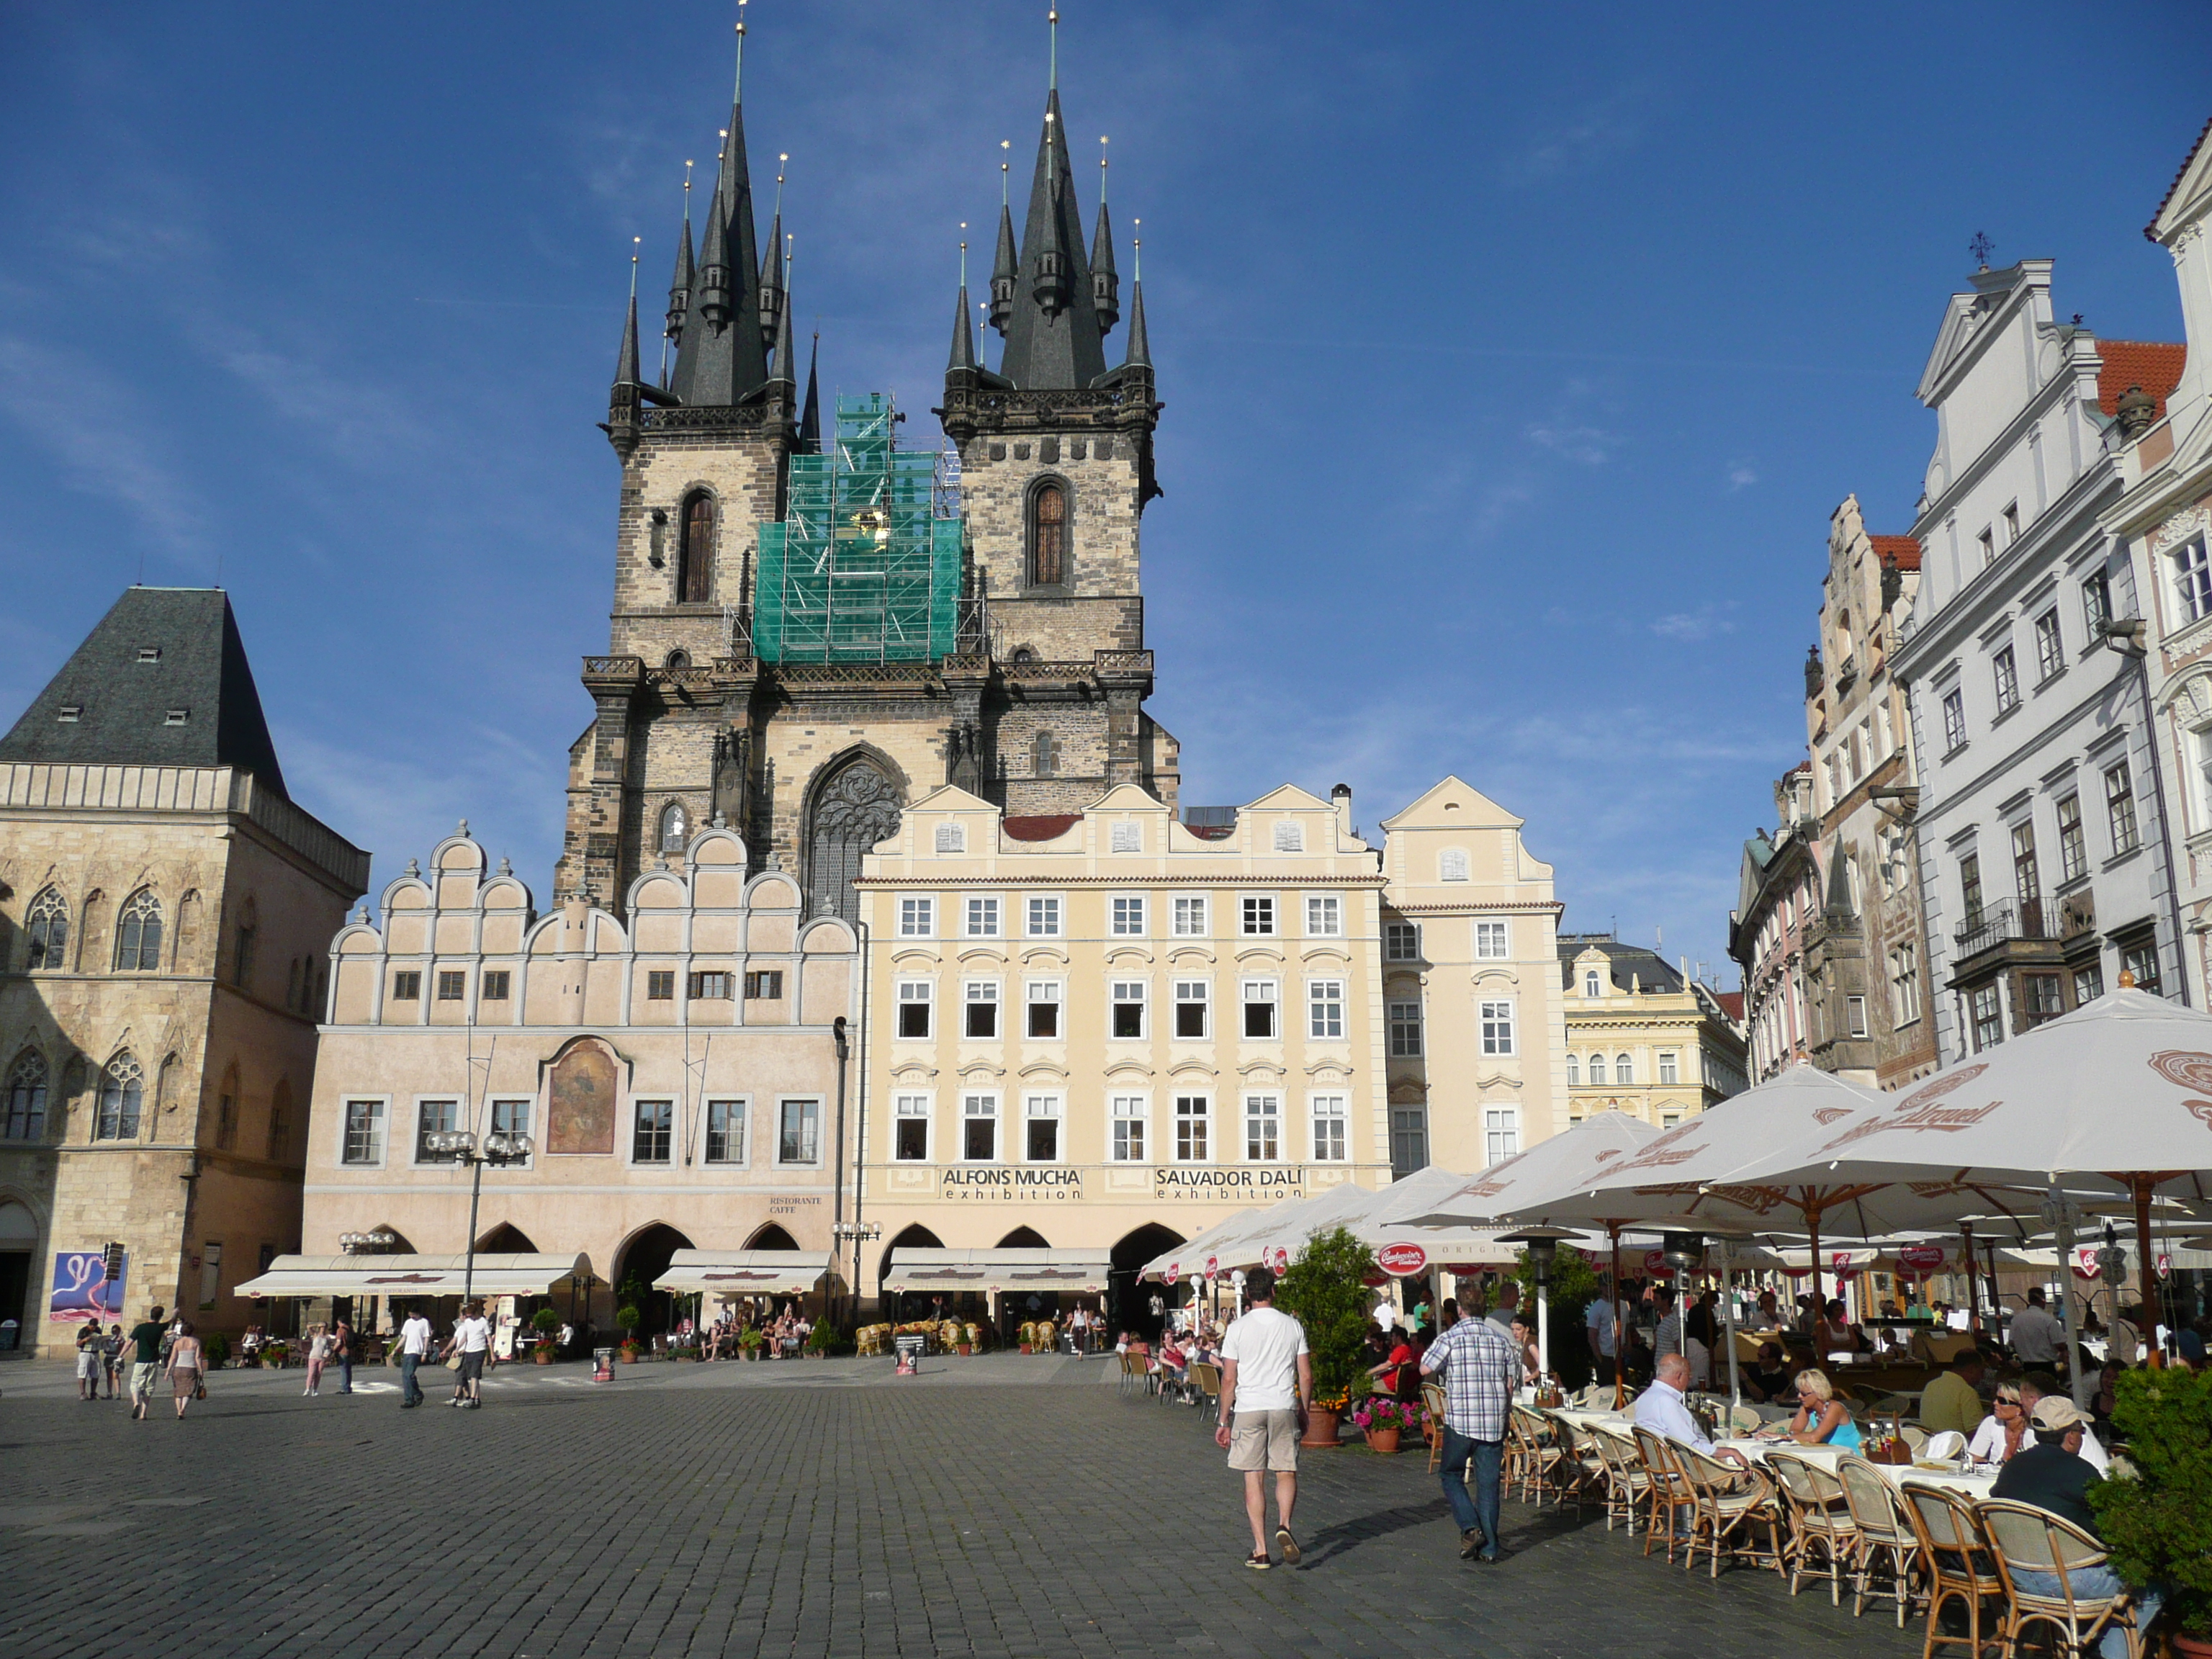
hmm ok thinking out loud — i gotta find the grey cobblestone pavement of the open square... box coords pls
[0,1354,1920,1659]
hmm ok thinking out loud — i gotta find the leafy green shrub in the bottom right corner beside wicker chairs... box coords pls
[2088,1367,2212,1659]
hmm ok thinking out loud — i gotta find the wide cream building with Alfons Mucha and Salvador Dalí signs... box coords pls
[858,786,1389,1316]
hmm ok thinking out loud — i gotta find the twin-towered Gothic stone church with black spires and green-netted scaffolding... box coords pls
[555,24,1177,918]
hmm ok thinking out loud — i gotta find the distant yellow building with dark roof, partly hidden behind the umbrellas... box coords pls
[1560,933,1750,1128]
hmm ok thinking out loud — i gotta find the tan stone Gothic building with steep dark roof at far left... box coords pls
[0,588,369,1354]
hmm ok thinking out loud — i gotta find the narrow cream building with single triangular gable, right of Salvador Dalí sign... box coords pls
[1382,776,1566,1174]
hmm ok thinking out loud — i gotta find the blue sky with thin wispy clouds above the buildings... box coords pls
[0,0,2212,984]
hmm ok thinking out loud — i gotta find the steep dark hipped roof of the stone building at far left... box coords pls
[0,588,285,794]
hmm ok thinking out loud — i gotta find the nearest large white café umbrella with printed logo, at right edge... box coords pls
[1737,974,2212,1362]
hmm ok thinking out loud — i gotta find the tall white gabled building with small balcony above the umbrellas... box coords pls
[1896,258,2185,1062]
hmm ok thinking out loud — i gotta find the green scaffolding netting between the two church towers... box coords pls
[752,392,960,662]
